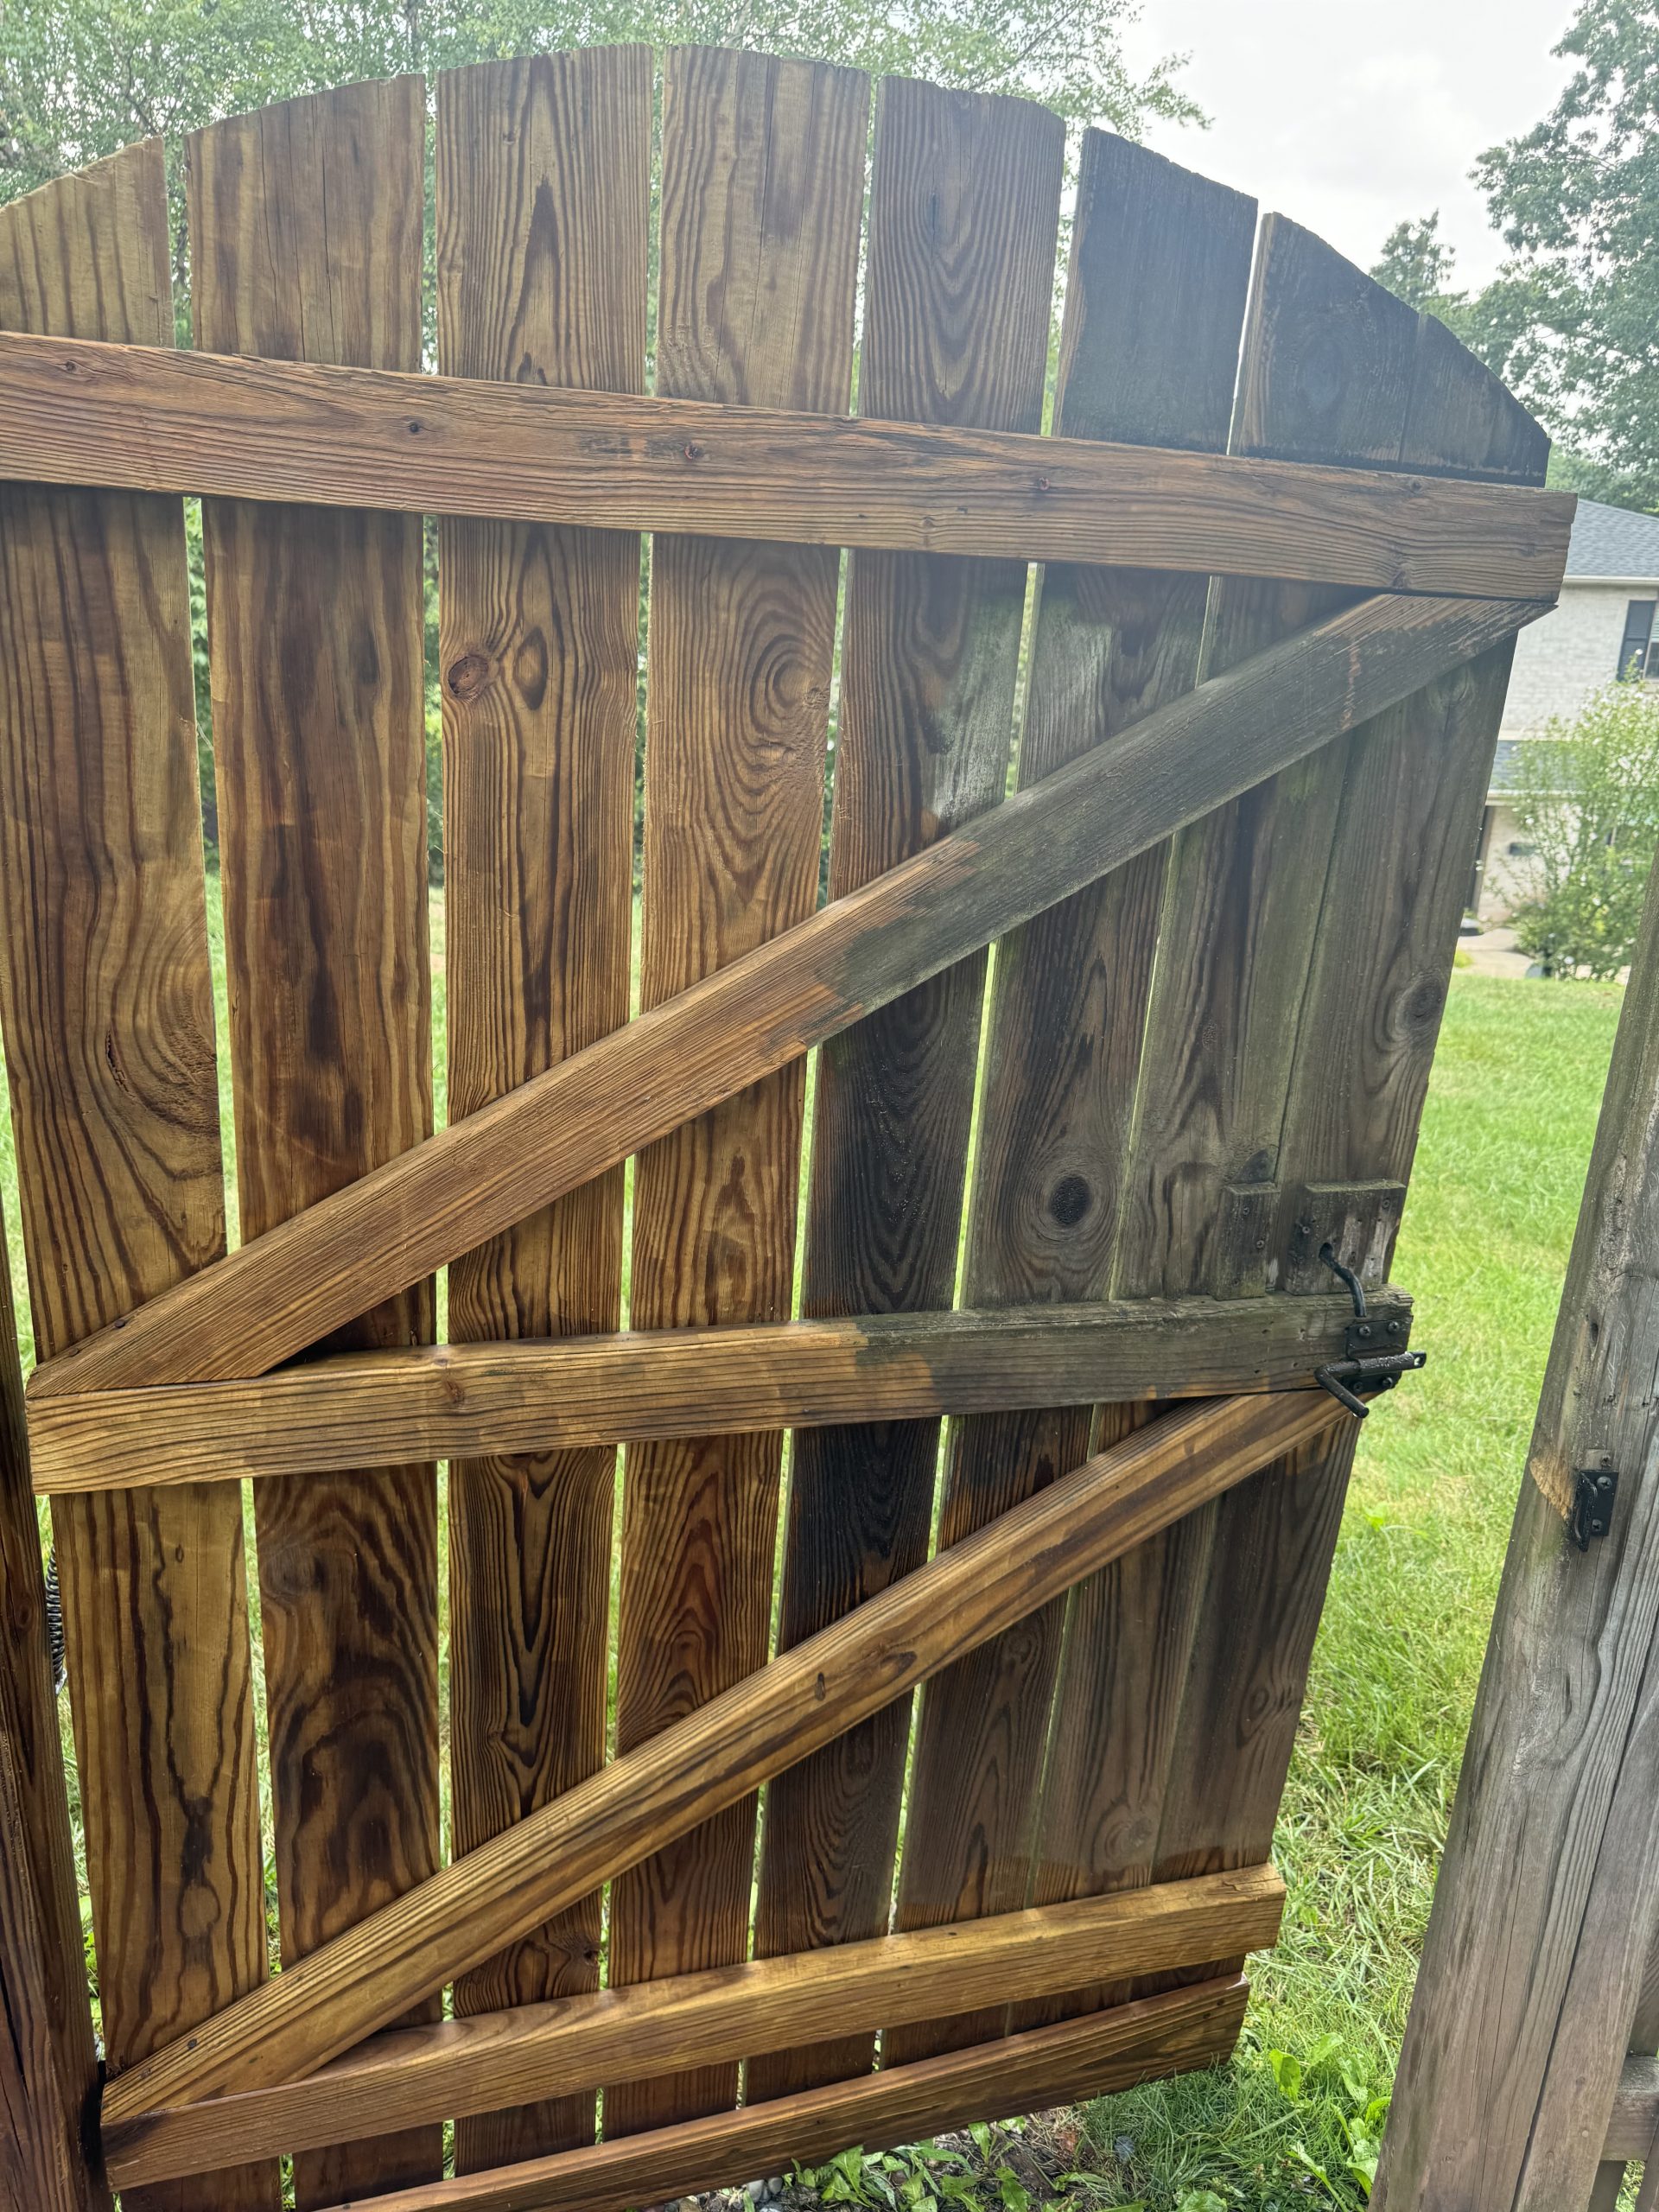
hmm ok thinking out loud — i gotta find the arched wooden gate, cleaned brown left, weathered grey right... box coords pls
[0,48,1571,2212]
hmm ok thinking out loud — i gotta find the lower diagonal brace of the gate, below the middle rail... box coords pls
[104,1391,1350,2126]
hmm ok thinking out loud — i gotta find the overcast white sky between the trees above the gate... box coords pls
[1126,0,1573,283]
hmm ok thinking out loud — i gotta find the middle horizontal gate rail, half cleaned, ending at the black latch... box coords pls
[29,1289,1411,1493]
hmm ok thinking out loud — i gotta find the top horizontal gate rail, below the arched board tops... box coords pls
[0,336,1575,600]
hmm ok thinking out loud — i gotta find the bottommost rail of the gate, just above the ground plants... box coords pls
[296,1978,1248,2212]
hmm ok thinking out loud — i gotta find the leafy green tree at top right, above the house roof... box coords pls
[1371,0,1659,509]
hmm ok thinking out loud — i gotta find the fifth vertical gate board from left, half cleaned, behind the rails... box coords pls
[746,78,1064,2101]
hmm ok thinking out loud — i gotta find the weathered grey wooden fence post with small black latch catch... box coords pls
[1371,849,1659,2212]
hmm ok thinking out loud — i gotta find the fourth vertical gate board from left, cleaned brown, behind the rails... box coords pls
[604,48,869,2137]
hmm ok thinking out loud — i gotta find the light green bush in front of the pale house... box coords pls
[1516,681,1659,980]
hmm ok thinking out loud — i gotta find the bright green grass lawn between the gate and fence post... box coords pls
[0,955,1619,2212]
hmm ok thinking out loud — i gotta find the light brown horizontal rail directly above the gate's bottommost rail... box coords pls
[104,1867,1285,2188]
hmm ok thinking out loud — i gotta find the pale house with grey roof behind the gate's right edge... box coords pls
[1471,500,1659,923]
